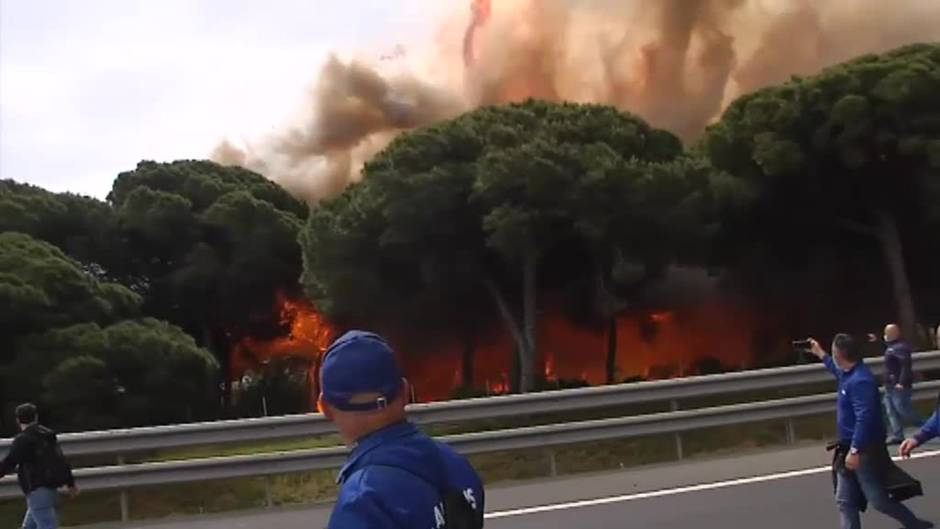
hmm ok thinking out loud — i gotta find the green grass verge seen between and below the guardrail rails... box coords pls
[0,388,932,527]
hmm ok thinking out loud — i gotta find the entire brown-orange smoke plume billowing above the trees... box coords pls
[213,0,940,202]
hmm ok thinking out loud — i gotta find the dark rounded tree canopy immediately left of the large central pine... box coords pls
[108,161,307,366]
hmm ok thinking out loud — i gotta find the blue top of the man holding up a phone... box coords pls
[823,356,885,450]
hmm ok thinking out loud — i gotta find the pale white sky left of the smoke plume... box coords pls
[0,0,455,198]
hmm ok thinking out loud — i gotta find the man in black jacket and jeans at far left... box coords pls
[0,404,78,529]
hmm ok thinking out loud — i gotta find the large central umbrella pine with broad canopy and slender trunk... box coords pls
[301,101,728,391]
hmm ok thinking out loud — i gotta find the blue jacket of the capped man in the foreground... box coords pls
[328,422,484,529]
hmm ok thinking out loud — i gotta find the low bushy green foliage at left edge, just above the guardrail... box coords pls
[0,232,218,428]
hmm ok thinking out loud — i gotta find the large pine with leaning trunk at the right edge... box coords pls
[703,44,940,342]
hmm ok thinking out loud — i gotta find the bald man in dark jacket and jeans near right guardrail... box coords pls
[872,323,924,444]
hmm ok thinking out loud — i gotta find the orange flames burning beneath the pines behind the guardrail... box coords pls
[232,294,787,402]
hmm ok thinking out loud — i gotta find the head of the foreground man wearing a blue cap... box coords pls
[319,331,409,444]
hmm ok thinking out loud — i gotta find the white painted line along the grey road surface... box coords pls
[484,450,940,520]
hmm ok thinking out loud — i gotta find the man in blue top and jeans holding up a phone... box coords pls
[809,334,933,529]
